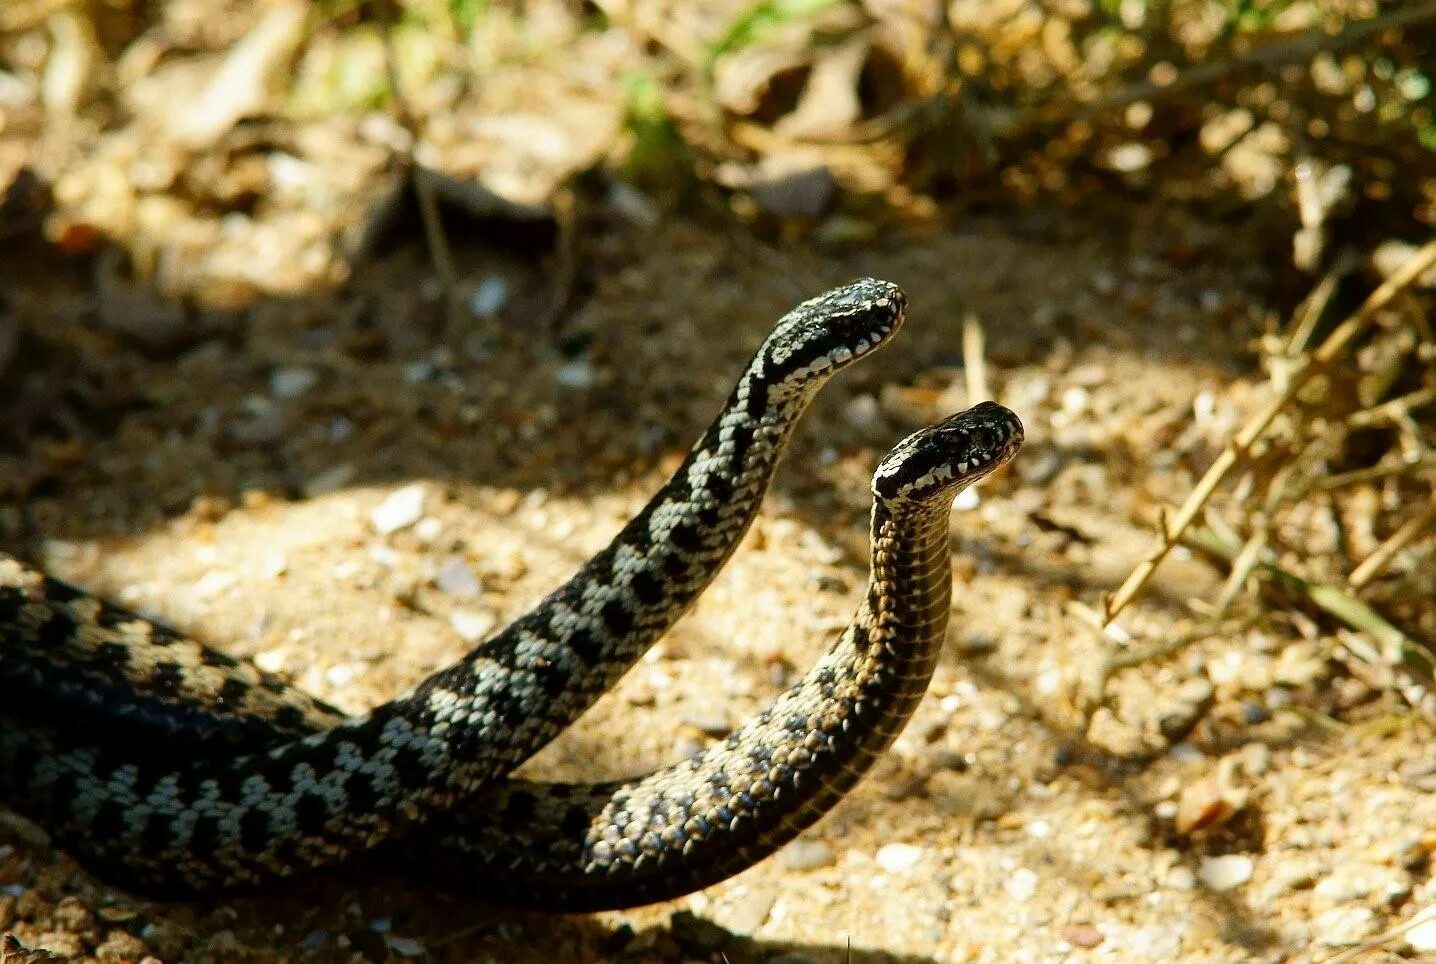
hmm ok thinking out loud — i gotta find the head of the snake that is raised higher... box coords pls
[758,277,908,394]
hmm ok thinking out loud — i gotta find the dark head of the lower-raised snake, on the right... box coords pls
[873,402,1022,501]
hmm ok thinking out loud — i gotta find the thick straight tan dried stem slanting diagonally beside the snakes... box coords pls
[1104,241,1436,625]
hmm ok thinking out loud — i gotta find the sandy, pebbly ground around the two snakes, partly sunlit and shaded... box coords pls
[0,213,1436,964]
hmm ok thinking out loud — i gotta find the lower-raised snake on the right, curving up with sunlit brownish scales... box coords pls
[0,402,1024,912]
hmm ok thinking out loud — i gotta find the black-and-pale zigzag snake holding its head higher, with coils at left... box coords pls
[0,279,906,896]
